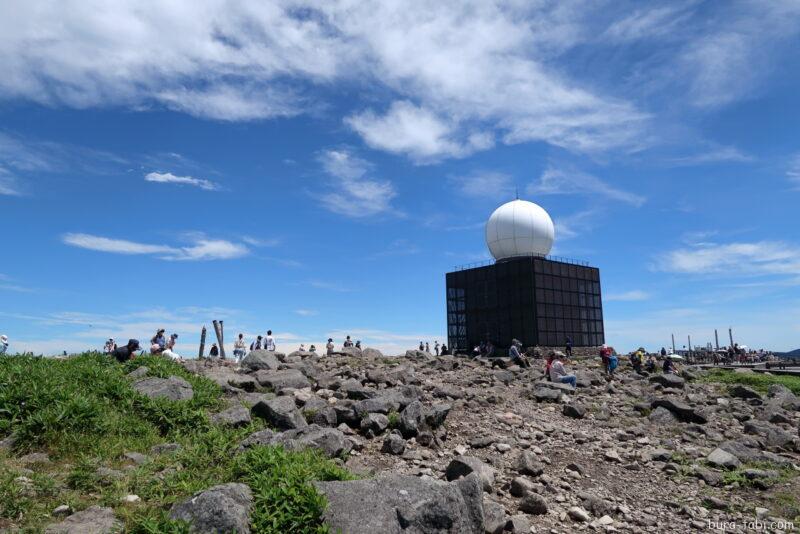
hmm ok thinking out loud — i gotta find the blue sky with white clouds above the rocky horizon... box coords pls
[0,0,800,354]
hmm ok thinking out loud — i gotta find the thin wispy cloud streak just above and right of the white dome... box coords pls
[527,167,647,207]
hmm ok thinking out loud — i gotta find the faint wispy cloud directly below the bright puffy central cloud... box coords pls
[315,150,397,218]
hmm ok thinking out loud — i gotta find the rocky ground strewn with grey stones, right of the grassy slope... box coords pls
[183,349,800,532]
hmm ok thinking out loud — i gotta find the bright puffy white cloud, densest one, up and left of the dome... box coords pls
[345,101,494,162]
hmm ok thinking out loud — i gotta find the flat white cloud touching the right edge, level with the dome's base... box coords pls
[653,241,800,276]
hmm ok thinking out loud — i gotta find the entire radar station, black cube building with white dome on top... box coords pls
[447,199,605,352]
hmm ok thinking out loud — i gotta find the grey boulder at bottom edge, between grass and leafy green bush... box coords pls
[169,483,253,534]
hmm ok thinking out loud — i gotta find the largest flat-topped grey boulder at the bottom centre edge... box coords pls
[314,475,484,534]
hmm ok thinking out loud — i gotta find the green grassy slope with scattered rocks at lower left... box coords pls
[0,353,350,533]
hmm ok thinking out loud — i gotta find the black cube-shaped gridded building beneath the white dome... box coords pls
[447,256,605,352]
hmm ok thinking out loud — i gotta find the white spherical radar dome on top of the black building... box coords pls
[486,199,555,260]
